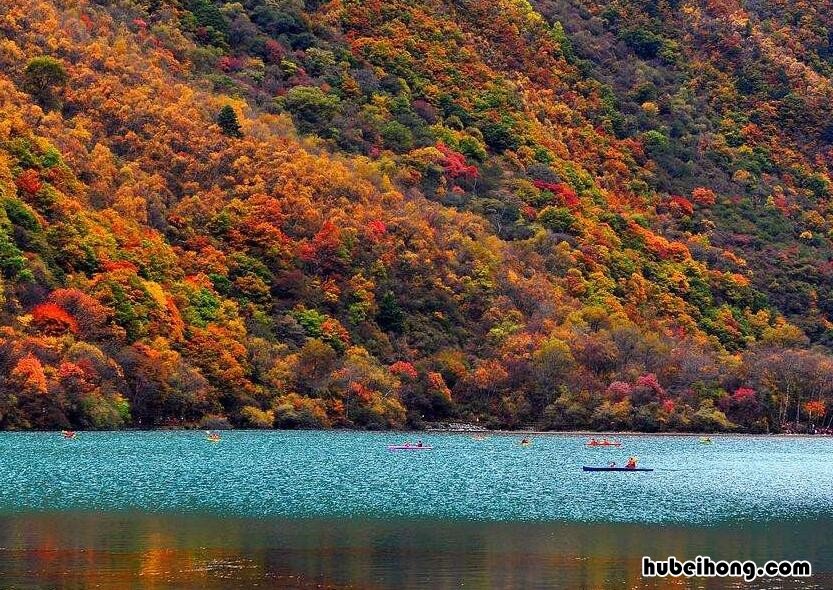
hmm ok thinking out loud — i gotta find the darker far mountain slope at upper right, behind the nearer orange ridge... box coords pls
[538,1,833,345]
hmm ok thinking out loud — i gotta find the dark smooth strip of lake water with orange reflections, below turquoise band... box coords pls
[0,513,833,590]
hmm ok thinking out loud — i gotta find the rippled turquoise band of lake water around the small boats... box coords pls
[0,431,833,525]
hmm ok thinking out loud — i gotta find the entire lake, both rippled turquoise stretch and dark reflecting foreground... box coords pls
[0,431,833,589]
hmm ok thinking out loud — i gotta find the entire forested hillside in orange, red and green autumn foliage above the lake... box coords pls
[0,0,833,431]
